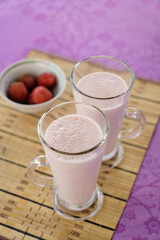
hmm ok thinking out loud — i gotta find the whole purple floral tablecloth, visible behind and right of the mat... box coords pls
[0,0,160,240]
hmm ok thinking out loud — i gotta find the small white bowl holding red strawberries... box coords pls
[0,59,66,113]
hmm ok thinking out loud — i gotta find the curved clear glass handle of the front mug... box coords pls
[27,156,54,187]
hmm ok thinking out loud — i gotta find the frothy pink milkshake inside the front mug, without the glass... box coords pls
[44,114,104,209]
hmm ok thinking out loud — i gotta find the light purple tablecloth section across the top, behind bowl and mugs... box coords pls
[0,0,160,81]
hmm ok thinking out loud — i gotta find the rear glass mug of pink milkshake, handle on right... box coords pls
[70,55,146,171]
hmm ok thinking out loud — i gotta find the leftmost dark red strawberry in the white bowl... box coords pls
[7,82,28,103]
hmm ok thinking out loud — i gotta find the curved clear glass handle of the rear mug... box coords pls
[119,107,146,139]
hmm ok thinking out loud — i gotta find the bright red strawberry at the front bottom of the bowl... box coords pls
[28,86,53,104]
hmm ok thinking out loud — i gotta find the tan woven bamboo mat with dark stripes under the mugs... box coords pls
[0,50,160,240]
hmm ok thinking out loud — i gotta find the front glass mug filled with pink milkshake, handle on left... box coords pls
[27,102,110,221]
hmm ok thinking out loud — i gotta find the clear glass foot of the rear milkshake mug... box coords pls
[100,143,124,172]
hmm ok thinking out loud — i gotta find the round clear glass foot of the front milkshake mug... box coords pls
[52,186,103,221]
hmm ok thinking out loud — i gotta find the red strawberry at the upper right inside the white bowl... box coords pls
[37,73,56,88]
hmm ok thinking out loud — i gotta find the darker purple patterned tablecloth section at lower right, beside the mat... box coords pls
[112,120,160,240]
